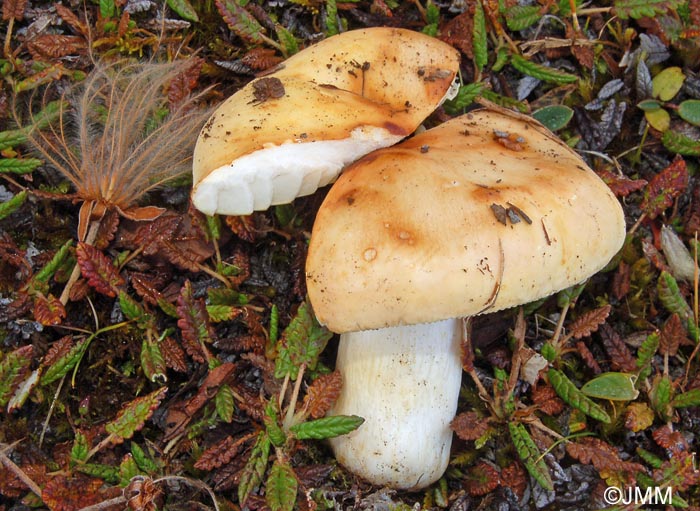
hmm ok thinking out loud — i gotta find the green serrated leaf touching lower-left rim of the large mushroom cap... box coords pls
[275,302,333,380]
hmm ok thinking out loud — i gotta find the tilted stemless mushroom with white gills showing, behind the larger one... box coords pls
[192,28,459,215]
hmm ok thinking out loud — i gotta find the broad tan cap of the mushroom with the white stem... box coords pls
[306,110,625,333]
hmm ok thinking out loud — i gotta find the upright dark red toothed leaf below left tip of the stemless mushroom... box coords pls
[177,280,214,363]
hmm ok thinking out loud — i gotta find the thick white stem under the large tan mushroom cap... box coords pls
[330,319,462,490]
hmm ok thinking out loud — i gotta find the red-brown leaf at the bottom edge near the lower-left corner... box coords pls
[41,474,104,511]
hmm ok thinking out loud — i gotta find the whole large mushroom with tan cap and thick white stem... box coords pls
[306,106,625,489]
